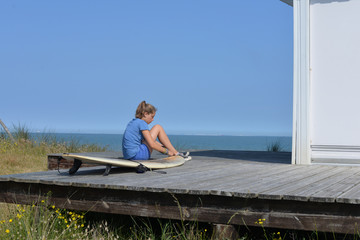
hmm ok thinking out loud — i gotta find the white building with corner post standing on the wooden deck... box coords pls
[282,0,360,164]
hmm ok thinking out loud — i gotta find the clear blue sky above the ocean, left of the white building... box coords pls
[0,0,293,136]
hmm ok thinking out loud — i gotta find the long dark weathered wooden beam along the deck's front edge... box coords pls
[0,181,360,234]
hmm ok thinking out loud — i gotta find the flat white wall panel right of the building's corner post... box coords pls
[310,0,360,163]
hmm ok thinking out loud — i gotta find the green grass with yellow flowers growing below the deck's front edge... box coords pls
[0,201,211,240]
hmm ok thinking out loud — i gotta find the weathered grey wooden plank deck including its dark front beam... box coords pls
[0,151,360,234]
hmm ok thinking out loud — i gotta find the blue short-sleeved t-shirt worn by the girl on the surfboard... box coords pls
[122,118,149,159]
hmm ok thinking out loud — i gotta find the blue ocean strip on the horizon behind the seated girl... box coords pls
[34,133,292,152]
